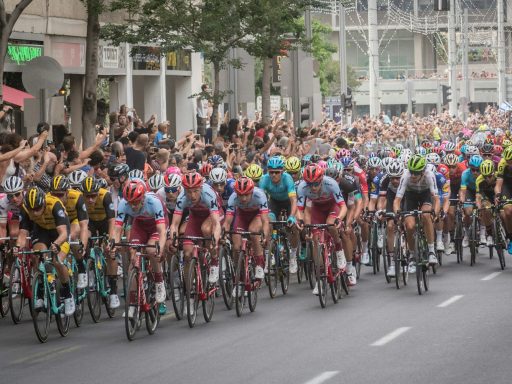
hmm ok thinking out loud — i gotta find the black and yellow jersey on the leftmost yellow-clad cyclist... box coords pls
[20,195,69,231]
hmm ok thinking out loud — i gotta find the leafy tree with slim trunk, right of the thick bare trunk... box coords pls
[103,0,250,136]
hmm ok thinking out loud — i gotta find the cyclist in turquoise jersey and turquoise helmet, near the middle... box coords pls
[259,156,299,273]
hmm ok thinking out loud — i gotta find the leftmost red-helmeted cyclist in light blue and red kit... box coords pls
[110,180,167,317]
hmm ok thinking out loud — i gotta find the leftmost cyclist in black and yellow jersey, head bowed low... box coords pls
[14,187,75,316]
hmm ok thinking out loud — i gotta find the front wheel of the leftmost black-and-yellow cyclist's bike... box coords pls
[31,271,51,343]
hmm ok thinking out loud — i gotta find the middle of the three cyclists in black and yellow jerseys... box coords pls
[50,175,89,289]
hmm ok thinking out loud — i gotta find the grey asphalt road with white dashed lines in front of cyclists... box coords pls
[0,248,512,384]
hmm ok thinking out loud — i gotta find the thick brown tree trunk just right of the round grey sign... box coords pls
[82,0,100,148]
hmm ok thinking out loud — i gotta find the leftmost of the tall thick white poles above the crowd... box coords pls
[368,0,380,117]
